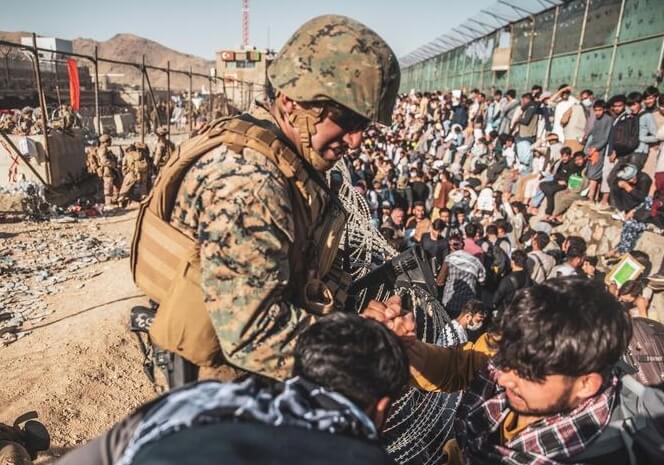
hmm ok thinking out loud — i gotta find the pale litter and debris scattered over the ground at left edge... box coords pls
[0,217,128,345]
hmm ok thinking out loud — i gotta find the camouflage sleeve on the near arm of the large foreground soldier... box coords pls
[172,146,314,379]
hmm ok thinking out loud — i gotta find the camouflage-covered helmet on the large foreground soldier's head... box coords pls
[268,15,400,124]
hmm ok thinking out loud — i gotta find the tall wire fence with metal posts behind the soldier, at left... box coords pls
[0,34,264,140]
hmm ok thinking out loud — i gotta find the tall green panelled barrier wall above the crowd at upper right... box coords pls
[401,0,664,97]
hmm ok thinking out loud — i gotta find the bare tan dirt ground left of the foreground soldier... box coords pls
[0,210,159,464]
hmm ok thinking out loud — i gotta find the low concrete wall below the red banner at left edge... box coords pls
[0,129,85,187]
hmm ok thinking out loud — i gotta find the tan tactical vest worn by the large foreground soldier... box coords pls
[131,117,350,366]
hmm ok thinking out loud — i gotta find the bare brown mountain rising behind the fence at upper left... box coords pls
[0,31,215,90]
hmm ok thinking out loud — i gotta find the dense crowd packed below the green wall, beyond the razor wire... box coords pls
[347,85,664,317]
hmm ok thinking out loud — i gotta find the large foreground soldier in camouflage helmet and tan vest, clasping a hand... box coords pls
[132,15,400,381]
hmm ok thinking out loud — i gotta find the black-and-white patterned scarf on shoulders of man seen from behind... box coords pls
[118,377,378,465]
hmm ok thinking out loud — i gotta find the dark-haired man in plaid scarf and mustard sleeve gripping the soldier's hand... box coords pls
[394,278,632,465]
